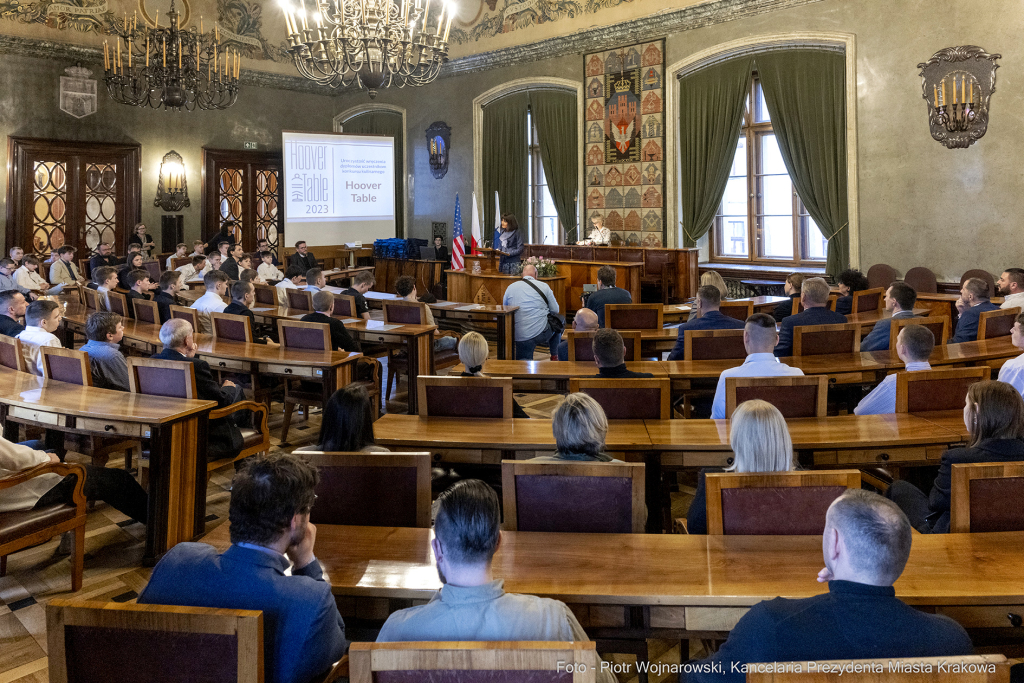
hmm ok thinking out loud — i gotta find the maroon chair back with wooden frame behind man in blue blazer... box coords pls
[46,599,263,683]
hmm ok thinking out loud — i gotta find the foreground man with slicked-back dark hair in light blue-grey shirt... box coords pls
[377,479,615,683]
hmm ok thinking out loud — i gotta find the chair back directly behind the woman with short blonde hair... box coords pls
[418,375,512,419]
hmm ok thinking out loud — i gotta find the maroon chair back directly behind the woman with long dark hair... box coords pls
[302,452,431,528]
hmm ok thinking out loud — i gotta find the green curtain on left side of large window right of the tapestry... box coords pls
[679,57,753,247]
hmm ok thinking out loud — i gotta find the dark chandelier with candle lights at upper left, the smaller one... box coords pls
[103,0,241,112]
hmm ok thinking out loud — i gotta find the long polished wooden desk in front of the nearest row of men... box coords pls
[197,524,1024,638]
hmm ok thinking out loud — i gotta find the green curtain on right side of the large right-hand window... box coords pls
[757,50,850,278]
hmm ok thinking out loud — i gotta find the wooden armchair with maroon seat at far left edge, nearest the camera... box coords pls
[0,463,86,593]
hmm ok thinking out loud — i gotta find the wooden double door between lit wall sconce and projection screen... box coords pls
[203,147,285,258]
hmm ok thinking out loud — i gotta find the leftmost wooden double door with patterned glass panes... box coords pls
[6,137,141,258]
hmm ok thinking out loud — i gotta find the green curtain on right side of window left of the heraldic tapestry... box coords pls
[529,90,580,245]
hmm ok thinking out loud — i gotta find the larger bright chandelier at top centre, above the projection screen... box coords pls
[282,0,455,98]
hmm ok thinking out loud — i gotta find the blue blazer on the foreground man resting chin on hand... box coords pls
[138,543,348,683]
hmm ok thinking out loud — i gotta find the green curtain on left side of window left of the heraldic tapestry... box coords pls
[477,92,529,237]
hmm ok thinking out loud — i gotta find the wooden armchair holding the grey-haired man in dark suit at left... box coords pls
[128,356,270,472]
